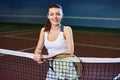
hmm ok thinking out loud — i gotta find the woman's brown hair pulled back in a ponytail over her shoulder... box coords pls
[44,4,62,31]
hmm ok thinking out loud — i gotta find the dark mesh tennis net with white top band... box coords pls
[0,49,120,80]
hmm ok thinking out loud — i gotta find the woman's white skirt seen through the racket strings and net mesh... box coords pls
[46,62,78,80]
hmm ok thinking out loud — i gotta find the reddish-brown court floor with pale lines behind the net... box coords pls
[0,24,120,57]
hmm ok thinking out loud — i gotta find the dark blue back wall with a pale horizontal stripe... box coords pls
[0,0,120,29]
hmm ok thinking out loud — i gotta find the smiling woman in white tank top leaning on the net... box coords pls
[34,4,74,80]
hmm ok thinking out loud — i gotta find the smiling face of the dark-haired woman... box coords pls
[48,8,63,25]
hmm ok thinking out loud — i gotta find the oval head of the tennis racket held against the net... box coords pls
[42,53,83,80]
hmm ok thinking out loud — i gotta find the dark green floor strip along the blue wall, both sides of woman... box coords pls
[0,22,120,34]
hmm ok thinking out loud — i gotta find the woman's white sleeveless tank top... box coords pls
[44,31,67,55]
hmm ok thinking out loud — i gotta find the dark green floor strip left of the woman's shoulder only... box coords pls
[0,23,43,32]
